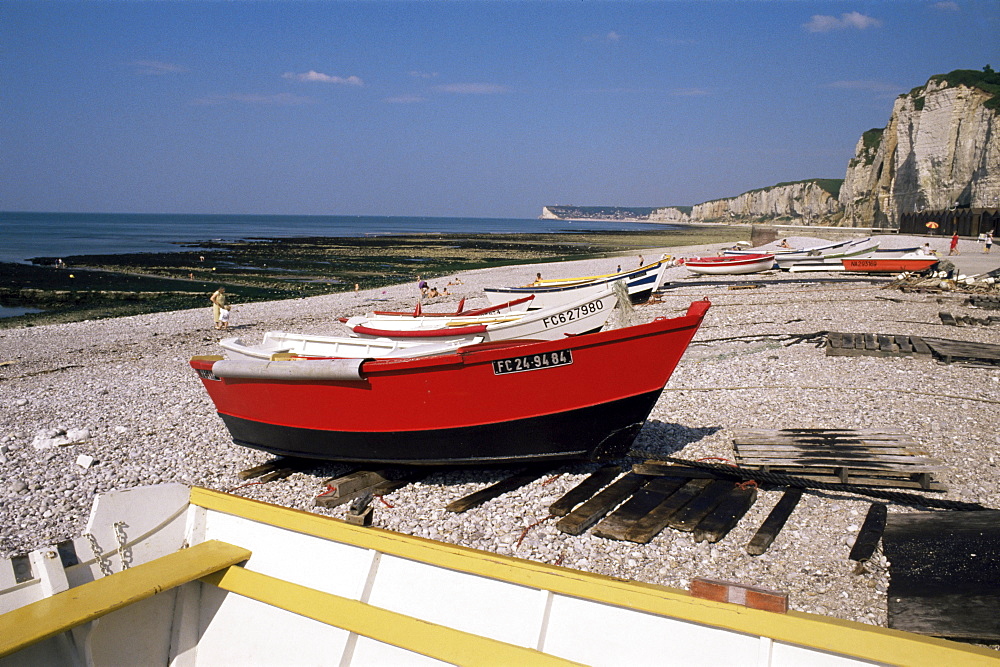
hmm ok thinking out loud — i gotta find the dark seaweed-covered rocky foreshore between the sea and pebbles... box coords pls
[0,228,739,328]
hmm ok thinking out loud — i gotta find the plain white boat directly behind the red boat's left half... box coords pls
[219,331,483,361]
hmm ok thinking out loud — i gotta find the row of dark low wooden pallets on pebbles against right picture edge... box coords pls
[826,331,1000,366]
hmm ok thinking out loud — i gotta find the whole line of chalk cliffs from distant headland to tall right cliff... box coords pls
[539,65,1000,229]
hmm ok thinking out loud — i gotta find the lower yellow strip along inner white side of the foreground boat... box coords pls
[202,567,580,666]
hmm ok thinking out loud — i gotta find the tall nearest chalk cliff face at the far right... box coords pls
[840,70,1000,227]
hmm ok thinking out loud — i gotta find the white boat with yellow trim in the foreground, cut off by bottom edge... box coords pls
[0,484,997,667]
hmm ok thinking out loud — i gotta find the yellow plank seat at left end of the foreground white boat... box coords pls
[0,540,250,658]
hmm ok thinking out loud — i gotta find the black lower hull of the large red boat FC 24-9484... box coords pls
[220,391,661,465]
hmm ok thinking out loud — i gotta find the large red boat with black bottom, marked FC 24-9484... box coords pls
[190,301,709,465]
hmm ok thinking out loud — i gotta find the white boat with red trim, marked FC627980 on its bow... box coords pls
[345,284,618,341]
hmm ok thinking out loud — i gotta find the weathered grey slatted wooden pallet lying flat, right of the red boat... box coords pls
[733,429,947,491]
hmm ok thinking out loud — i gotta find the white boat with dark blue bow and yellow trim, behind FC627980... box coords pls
[484,259,670,309]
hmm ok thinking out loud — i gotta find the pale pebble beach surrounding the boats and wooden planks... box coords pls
[0,236,1000,626]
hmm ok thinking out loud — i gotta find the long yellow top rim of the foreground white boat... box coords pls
[191,487,1000,667]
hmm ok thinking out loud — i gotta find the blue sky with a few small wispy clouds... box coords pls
[0,0,1000,218]
